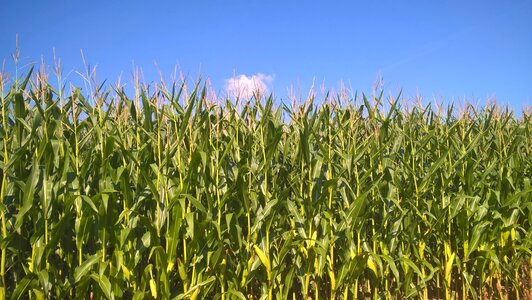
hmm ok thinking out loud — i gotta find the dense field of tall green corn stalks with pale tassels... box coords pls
[0,69,532,299]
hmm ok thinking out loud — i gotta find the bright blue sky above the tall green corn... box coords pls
[0,0,532,111]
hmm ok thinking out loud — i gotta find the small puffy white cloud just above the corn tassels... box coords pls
[225,73,273,99]
